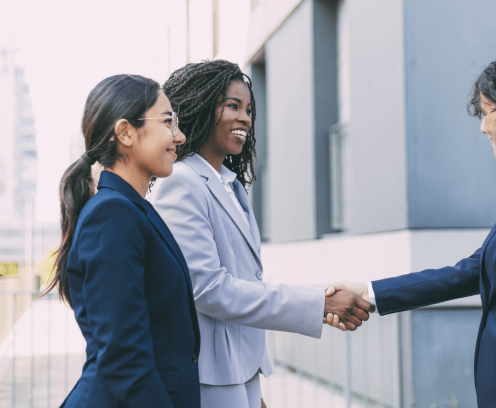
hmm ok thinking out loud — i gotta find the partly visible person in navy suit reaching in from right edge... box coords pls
[327,61,496,408]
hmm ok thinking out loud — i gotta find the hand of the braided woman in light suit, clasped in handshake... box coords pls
[324,290,374,331]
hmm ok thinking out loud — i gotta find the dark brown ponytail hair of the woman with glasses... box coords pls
[43,75,160,306]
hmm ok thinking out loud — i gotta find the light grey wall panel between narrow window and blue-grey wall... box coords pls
[340,0,407,233]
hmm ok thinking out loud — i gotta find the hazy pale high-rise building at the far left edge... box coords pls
[0,20,60,282]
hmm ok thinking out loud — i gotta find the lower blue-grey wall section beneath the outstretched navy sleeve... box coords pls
[412,308,482,407]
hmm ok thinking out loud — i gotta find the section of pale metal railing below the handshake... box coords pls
[262,315,408,408]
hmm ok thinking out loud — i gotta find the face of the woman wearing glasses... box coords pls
[132,91,186,178]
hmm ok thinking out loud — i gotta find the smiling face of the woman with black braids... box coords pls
[202,80,252,169]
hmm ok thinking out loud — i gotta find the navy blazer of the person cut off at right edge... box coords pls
[372,225,496,408]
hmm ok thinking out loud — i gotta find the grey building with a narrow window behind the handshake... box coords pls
[156,0,496,407]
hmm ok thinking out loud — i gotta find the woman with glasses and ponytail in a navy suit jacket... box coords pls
[43,75,200,408]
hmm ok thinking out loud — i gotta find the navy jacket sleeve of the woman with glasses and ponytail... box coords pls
[77,199,173,408]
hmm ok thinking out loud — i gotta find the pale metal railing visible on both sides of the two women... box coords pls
[0,290,401,408]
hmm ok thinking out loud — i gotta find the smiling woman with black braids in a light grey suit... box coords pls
[151,60,370,408]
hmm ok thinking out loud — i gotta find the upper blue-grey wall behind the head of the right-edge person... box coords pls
[405,0,496,228]
